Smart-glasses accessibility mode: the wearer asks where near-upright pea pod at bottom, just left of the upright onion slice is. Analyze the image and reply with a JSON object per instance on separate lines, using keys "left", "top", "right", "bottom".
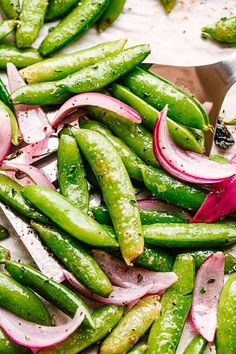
{"left": 147, "top": 254, "right": 195, "bottom": 354}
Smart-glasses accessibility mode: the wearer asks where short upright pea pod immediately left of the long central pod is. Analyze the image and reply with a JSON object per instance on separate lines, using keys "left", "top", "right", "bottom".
{"left": 57, "top": 134, "right": 89, "bottom": 213}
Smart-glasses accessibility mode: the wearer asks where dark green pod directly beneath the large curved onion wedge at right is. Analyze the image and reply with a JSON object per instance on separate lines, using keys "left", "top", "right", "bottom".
{"left": 141, "top": 165, "right": 207, "bottom": 210}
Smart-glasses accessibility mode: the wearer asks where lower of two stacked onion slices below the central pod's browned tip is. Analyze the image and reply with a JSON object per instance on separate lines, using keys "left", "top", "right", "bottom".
{"left": 64, "top": 271, "right": 152, "bottom": 305}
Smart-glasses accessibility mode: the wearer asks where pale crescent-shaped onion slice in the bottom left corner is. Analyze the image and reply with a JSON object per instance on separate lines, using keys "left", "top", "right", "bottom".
{"left": 0, "top": 307, "right": 84, "bottom": 349}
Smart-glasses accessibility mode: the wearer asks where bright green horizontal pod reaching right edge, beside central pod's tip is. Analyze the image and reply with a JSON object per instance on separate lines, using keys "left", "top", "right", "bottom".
{"left": 143, "top": 224, "right": 236, "bottom": 248}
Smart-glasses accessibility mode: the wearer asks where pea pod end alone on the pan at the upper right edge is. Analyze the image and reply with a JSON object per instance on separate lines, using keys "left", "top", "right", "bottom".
{"left": 202, "top": 16, "right": 236, "bottom": 44}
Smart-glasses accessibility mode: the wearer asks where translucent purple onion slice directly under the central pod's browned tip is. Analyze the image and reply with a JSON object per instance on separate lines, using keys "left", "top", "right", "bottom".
{"left": 92, "top": 250, "right": 178, "bottom": 294}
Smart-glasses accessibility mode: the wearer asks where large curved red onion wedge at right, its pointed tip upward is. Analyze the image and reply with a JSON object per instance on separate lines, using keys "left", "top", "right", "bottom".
{"left": 153, "top": 107, "right": 236, "bottom": 184}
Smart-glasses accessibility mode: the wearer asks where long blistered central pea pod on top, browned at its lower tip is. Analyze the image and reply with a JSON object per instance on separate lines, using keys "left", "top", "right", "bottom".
{"left": 73, "top": 128, "right": 144, "bottom": 265}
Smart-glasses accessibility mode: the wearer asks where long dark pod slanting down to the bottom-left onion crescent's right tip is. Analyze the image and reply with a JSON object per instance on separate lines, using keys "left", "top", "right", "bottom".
{"left": 5, "top": 261, "right": 94, "bottom": 328}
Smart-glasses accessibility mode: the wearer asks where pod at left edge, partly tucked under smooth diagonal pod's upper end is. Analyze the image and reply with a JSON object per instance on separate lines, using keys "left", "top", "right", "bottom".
{"left": 0, "top": 174, "right": 47, "bottom": 222}
